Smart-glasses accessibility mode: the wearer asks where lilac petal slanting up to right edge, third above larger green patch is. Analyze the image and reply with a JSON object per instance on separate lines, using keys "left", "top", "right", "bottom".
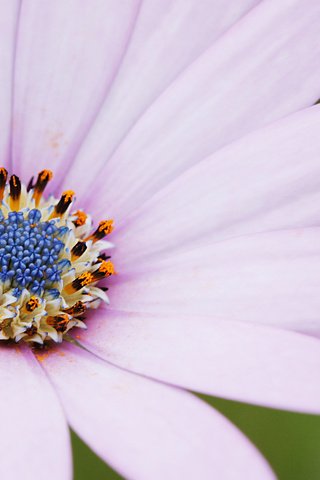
{"left": 114, "top": 107, "right": 320, "bottom": 265}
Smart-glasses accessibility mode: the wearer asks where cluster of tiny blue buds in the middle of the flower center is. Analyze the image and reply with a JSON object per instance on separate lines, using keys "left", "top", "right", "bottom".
{"left": 0, "top": 209, "right": 70, "bottom": 297}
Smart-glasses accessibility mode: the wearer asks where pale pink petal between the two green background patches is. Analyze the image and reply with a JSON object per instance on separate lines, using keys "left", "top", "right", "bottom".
{"left": 42, "top": 346, "right": 273, "bottom": 480}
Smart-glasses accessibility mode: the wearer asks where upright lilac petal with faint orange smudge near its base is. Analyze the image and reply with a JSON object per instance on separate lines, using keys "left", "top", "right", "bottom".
{"left": 13, "top": 0, "right": 138, "bottom": 187}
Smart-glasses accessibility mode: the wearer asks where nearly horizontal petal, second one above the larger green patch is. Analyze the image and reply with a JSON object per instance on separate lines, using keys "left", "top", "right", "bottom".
{"left": 109, "top": 229, "right": 320, "bottom": 335}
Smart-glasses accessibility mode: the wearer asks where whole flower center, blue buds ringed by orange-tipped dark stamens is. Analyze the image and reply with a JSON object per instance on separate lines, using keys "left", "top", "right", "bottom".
{"left": 0, "top": 168, "right": 114, "bottom": 344}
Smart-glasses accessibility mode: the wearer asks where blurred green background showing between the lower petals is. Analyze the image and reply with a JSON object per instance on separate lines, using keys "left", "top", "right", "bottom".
{"left": 72, "top": 396, "right": 320, "bottom": 480}
